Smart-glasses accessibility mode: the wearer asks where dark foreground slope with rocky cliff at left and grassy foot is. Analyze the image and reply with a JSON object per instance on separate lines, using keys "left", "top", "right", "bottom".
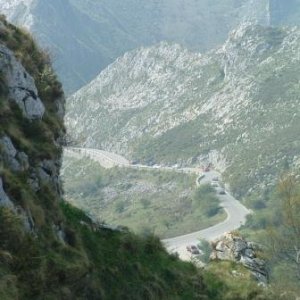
{"left": 0, "top": 19, "right": 267, "bottom": 300}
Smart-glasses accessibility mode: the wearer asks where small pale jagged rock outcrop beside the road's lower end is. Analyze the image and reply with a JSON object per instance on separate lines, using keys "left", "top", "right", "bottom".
{"left": 210, "top": 233, "right": 268, "bottom": 284}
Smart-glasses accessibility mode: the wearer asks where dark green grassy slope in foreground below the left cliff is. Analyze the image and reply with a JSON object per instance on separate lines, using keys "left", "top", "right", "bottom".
{"left": 0, "top": 203, "right": 205, "bottom": 300}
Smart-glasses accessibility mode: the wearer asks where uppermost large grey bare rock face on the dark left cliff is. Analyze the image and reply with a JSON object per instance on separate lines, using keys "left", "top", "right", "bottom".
{"left": 0, "top": 45, "right": 45, "bottom": 120}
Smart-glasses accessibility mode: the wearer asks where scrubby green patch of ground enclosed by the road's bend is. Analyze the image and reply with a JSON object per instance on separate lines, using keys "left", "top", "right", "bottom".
{"left": 63, "top": 157, "right": 225, "bottom": 237}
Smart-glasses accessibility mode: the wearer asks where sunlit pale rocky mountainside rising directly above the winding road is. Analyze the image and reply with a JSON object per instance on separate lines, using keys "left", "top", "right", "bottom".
{"left": 66, "top": 24, "right": 300, "bottom": 194}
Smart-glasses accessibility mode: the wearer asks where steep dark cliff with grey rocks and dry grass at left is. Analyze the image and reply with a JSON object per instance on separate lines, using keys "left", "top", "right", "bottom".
{"left": 0, "top": 18, "right": 65, "bottom": 238}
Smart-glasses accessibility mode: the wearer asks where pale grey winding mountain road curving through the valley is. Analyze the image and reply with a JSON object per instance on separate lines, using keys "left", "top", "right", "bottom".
{"left": 64, "top": 147, "right": 251, "bottom": 260}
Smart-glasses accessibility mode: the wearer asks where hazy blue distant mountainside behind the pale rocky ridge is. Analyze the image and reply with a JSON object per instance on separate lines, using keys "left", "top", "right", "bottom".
{"left": 0, "top": 0, "right": 269, "bottom": 92}
